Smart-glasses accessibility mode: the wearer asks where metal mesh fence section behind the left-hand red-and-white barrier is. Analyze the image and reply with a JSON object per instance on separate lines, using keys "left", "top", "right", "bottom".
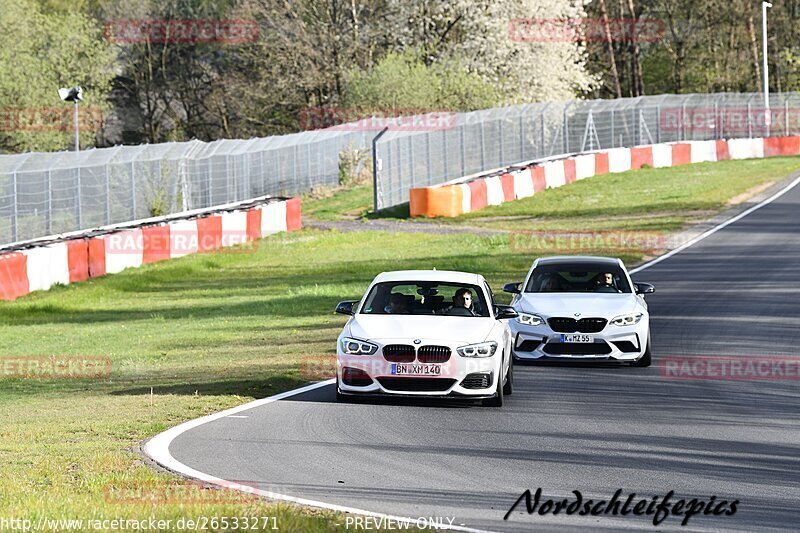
{"left": 0, "top": 130, "right": 374, "bottom": 244}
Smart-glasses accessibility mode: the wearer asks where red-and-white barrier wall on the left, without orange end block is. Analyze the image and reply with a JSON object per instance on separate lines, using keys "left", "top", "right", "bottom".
{"left": 0, "top": 198, "right": 302, "bottom": 300}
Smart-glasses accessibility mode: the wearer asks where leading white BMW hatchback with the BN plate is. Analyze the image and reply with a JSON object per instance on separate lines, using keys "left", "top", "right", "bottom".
{"left": 336, "top": 270, "right": 517, "bottom": 406}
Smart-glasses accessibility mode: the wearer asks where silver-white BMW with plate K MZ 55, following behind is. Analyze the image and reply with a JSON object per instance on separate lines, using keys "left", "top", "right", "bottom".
{"left": 503, "top": 256, "right": 655, "bottom": 366}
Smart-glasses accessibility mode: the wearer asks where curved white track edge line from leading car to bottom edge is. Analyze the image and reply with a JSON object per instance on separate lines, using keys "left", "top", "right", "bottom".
{"left": 142, "top": 379, "right": 490, "bottom": 533}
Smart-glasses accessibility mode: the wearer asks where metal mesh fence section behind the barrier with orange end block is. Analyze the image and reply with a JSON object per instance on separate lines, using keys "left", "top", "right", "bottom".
{"left": 374, "top": 93, "right": 800, "bottom": 209}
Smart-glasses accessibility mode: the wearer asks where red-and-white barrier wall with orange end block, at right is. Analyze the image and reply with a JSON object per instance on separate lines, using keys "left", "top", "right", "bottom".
{"left": 409, "top": 136, "right": 800, "bottom": 217}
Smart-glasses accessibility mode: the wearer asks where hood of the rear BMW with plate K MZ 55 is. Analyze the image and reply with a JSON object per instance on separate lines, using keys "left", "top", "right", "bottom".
{"left": 514, "top": 292, "right": 638, "bottom": 320}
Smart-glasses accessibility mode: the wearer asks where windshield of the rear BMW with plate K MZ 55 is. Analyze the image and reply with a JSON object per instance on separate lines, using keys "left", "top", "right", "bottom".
{"left": 525, "top": 263, "right": 631, "bottom": 294}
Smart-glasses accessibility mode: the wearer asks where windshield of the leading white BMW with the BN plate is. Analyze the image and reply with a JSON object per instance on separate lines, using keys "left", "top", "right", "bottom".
{"left": 361, "top": 281, "right": 489, "bottom": 317}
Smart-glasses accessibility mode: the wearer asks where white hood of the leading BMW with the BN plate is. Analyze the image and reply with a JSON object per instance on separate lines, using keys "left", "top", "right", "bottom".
{"left": 349, "top": 314, "right": 495, "bottom": 343}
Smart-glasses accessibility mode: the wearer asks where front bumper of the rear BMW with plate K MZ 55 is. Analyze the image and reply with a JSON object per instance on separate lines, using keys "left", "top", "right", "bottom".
{"left": 511, "top": 318, "right": 649, "bottom": 363}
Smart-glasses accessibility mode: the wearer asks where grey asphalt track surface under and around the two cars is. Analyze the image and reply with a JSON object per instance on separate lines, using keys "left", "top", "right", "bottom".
{"left": 169, "top": 178, "right": 800, "bottom": 531}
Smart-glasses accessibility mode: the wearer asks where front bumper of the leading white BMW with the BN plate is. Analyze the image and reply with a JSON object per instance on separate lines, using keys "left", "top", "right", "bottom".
{"left": 336, "top": 341, "right": 501, "bottom": 399}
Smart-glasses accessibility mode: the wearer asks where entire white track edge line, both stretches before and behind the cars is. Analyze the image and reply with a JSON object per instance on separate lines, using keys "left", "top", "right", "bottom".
{"left": 143, "top": 172, "right": 800, "bottom": 533}
